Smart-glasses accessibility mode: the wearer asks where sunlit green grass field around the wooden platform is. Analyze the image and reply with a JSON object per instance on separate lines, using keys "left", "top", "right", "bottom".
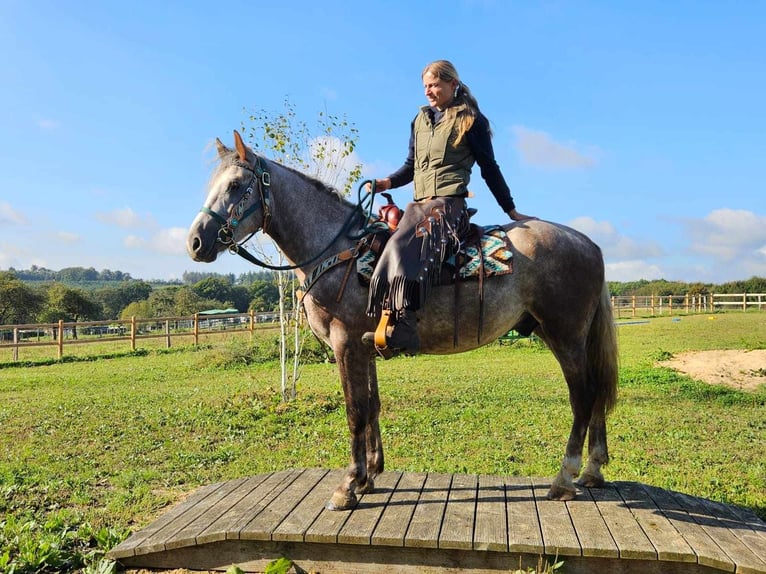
{"left": 0, "top": 312, "right": 766, "bottom": 573}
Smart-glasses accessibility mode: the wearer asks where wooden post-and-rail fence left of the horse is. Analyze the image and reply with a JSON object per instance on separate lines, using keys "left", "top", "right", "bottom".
{"left": 0, "top": 311, "right": 279, "bottom": 362}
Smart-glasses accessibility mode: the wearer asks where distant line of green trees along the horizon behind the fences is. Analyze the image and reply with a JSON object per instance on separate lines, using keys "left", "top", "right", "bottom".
{"left": 0, "top": 266, "right": 766, "bottom": 325}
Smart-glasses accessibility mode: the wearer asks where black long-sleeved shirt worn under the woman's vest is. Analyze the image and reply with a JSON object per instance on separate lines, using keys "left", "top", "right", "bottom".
{"left": 389, "top": 108, "right": 515, "bottom": 213}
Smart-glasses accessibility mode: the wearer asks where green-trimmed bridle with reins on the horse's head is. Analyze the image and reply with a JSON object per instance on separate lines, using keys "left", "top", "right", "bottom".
{"left": 200, "top": 155, "right": 375, "bottom": 271}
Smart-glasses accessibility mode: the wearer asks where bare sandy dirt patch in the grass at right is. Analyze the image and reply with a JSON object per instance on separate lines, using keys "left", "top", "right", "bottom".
{"left": 657, "top": 349, "right": 766, "bottom": 391}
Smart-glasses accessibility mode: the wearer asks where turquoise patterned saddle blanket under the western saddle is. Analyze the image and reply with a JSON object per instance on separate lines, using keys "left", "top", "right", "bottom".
{"left": 356, "top": 225, "right": 513, "bottom": 282}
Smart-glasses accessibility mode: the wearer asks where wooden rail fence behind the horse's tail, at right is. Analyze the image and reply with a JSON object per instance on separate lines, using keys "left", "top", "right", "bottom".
{"left": 612, "top": 293, "right": 766, "bottom": 319}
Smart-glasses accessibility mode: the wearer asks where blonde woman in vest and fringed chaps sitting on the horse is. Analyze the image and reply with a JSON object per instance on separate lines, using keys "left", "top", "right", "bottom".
{"left": 362, "top": 60, "right": 530, "bottom": 354}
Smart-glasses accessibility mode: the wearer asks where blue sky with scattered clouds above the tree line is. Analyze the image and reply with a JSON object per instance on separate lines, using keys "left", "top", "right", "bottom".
{"left": 0, "top": 0, "right": 766, "bottom": 283}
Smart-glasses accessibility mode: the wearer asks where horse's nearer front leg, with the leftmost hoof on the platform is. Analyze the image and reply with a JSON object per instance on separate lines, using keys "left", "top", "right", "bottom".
{"left": 326, "top": 344, "right": 370, "bottom": 510}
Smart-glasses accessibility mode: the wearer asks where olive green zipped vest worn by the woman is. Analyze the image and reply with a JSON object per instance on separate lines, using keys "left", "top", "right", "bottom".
{"left": 414, "top": 104, "right": 475, "bottom": 200}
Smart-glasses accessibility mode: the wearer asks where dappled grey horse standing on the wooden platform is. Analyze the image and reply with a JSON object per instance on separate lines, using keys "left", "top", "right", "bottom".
{"left": 186, "top": 131, "right": 618, "bottom": 510}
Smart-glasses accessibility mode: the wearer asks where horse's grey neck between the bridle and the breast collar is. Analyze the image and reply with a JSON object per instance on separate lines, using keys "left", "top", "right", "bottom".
{"left": 268, "top": 165, "right": 352, "bottom": 280}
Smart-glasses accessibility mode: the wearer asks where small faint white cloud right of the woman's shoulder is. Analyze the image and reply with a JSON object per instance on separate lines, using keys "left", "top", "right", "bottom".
{"left": 513, "top": 126, "right": 598, "bottom": 169}
